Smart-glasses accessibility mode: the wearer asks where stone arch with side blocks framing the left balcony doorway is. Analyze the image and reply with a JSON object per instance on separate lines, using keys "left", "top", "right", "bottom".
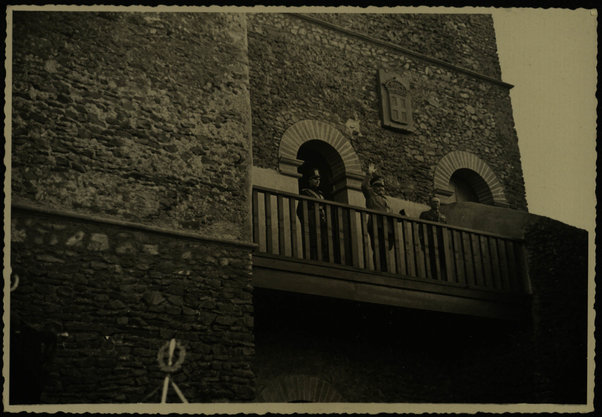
{"left": 278, "top": 120, "right": 362, "bottom": 179}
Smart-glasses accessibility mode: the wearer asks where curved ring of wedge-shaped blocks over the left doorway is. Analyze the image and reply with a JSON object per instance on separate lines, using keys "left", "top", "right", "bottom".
{"left": 278, "top": 120, "right": 361, "bottom": 173}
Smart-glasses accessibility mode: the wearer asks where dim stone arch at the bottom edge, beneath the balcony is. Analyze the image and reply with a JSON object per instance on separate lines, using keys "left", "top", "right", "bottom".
{"left": 255, "top": 375, "right": 344, "bottom": 403}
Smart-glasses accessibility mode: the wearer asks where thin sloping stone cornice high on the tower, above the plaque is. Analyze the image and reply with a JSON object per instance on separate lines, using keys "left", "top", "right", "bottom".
{"left": 290, "top": 13, "right": 514, "bottom": 89}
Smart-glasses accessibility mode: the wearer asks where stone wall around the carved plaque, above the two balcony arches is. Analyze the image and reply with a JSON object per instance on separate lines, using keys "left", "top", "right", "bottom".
{"left": 248, "top": 14, "right": 526, "bottom": 210}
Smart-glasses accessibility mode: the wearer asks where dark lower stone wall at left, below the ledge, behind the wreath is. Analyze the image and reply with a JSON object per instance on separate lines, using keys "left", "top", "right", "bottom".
{"left": 11, "top": 210, "right": 254, "bottom": 403}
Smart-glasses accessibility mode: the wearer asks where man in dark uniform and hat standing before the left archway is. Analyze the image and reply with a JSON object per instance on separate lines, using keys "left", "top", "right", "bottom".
{"left": 297, "top": 169, "right": 328, "bottom": 261}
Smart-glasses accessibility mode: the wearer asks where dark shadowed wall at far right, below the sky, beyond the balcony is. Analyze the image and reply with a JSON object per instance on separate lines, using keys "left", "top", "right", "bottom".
{"left": 525, "top": 216, "right": 588, "bottom": 403}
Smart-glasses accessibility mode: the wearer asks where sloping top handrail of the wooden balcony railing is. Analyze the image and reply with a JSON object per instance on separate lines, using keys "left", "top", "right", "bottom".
{"left": 253, "top": 185, "right": 524, "bottom": 242}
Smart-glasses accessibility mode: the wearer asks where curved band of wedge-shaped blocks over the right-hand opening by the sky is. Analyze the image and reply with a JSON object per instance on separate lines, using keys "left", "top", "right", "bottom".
{"left": 433, "top": 151, "right": 507, "bottom": 205}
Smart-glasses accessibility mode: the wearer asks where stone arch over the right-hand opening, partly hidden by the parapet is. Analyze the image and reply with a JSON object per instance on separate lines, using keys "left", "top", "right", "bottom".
{"left": 433, "top": 151, "right": 508, "bottom": 207}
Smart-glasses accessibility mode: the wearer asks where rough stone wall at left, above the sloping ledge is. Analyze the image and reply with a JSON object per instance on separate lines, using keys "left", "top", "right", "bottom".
{"left": 12, "top": 12, "right": 251, "bottom": 239}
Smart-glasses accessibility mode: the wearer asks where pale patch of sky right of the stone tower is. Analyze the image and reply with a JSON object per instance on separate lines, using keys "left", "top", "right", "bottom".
{"left": 491, "top": 8, "right": 597, "bottom": 235}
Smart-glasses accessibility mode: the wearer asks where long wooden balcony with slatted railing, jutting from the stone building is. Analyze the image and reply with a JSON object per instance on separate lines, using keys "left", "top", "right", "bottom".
{"left": 252, "top": 186, "right": 531, "bottom": 319}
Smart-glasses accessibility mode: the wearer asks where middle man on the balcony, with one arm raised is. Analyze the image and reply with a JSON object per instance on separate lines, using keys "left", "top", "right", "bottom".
{"left": 362, "top": 164, "right": 395, "bottom": 271}
